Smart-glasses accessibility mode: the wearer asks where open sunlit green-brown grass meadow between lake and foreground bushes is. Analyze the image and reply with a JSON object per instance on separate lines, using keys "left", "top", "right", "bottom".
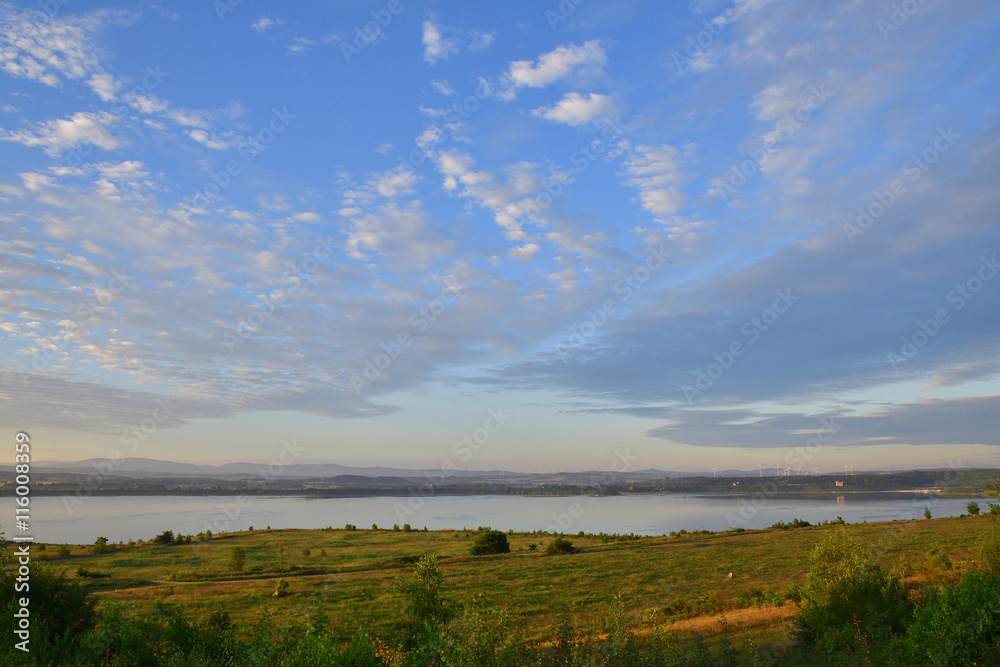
{"left": 36, "top": 516, "right": 990, "bottom": 641}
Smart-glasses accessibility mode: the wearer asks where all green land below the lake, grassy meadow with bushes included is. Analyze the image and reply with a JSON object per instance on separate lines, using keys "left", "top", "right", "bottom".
{"left": 0, "top": 490, "right": 1000, "bottom": 666}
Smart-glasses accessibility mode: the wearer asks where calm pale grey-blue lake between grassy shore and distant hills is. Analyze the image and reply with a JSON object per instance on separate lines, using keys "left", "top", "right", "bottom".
{"left": 27, "top": 494, "right": 987, "bottom": 544}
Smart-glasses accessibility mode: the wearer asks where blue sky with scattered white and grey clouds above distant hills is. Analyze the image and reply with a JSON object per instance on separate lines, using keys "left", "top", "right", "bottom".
{"left": 0, "top": 0, "right": 1000, "bottom": 473}
